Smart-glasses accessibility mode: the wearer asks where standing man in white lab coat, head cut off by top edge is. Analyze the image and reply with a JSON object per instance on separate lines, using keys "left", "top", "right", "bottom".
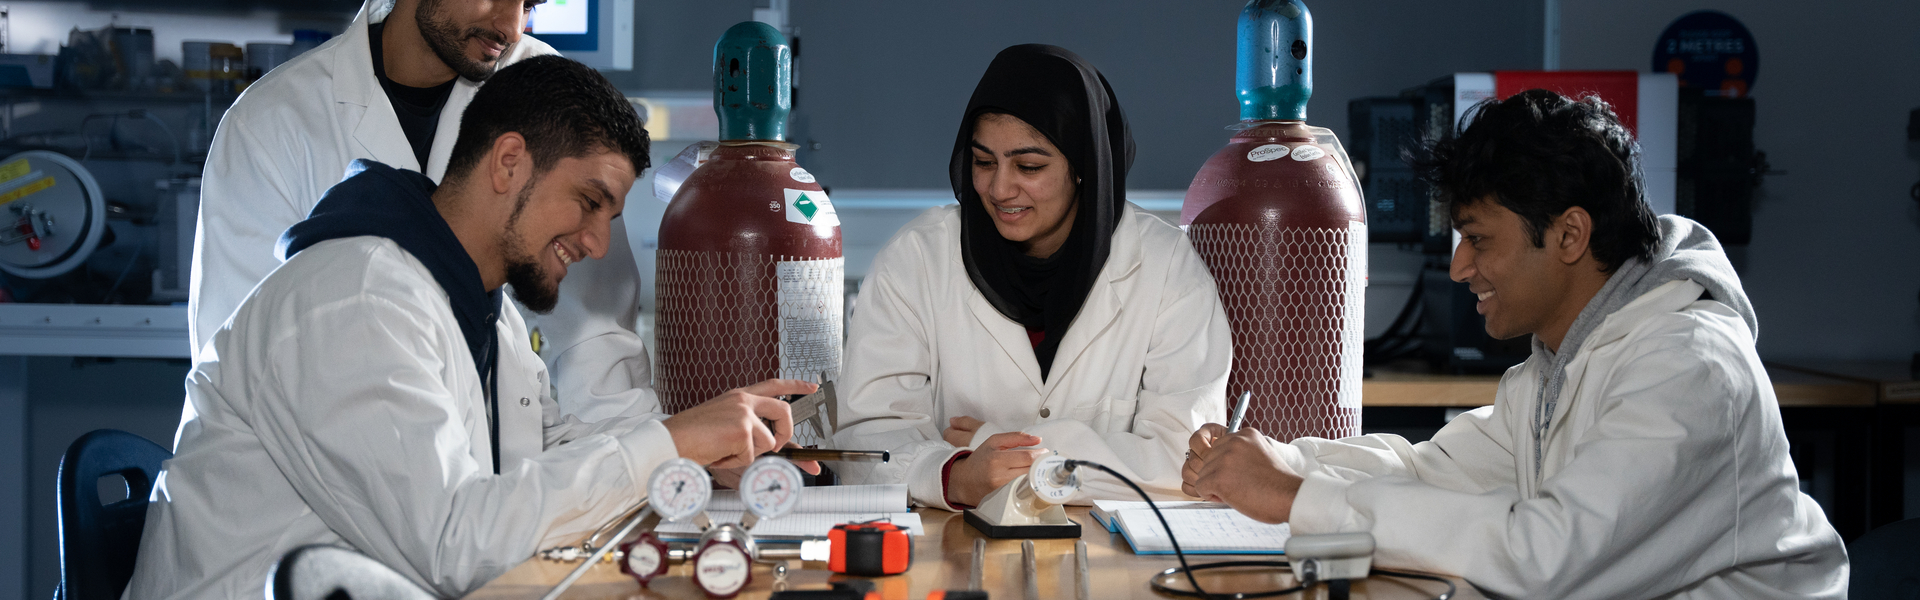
{"left": 188, "top": 0, "right": 659, "bottom": 430}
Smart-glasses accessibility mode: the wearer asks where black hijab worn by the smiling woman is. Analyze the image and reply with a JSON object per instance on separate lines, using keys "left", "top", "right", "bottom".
{"left": 948, "top": 44, "right": 1133, "bottom": 379}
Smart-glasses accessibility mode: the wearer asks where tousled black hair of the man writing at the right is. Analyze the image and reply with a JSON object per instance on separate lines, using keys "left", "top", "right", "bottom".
{"left": 1413, "top": 88, "right": 1659, "bottom": 273}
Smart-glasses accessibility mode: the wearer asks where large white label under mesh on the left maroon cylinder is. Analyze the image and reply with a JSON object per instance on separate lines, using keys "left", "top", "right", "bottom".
{"left": 774, "top": 258, "right": 847, "bottom": 383}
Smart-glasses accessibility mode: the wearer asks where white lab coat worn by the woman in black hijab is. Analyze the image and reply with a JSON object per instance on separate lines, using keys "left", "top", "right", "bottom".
{"left": 833, "top": 204, "right": 1233, "bottom": 510}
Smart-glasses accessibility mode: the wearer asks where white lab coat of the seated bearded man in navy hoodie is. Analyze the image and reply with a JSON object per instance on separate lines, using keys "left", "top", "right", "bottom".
{"left": 125, "top": 237, "right": 678, "bottom": 600}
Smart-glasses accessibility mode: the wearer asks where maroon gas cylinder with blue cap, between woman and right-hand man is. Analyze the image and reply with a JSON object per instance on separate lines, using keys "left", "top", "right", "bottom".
{"left": 1181, "top": 0, "right": 1367, "bottom": 440}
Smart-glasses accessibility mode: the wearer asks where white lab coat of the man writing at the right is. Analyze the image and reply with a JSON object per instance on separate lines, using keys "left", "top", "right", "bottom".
{"left": 1281, "top": 279, "right": 1847, "bottom": 598}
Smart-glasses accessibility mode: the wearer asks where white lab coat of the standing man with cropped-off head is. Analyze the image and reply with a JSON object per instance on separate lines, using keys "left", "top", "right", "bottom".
{"left": 188, "top": 0, "right": 659, "bottom": 421}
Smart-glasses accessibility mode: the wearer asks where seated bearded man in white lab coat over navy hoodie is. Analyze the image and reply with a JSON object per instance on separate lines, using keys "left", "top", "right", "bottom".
{"left": 127, "top": 56, "right": 814, "bottom": 598}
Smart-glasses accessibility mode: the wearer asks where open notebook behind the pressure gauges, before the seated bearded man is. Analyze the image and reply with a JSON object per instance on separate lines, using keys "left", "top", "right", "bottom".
{"left": 653, "top": 485, "right": 925, "bottom": 542}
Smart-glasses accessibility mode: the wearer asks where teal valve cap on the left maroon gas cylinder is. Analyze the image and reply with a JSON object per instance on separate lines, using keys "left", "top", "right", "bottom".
{"left": 714, "top": 21, "right": 793, "bottom": 140}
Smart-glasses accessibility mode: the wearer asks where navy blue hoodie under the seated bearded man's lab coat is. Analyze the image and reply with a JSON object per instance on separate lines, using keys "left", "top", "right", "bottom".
{"left": 278, "top": 158, "right": 505, "bottom": 469}
